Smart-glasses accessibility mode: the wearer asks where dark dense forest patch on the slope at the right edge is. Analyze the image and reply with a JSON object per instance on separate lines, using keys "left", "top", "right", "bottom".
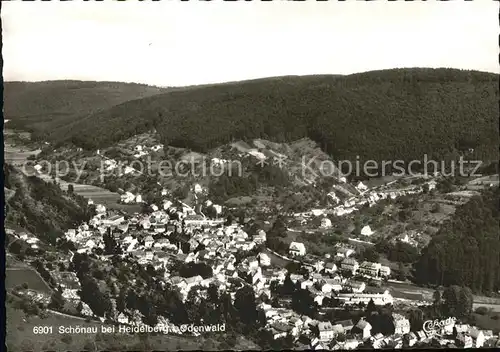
{"left": 415, "top": 187, "right": 500, "bottom": 293}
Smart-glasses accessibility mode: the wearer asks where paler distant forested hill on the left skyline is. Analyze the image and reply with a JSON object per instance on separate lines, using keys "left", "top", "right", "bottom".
{"left": 4, "top": 81, "right": 166, "bottom": 134}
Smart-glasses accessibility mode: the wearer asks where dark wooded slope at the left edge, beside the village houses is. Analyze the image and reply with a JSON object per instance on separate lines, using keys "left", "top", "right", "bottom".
{"left": 3, "top": 164, "right": 93, "bottom": 244}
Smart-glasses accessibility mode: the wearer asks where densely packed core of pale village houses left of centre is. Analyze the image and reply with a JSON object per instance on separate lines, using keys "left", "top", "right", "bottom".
{"left": 66, "top": 197, "right": 278, "bottom": 304}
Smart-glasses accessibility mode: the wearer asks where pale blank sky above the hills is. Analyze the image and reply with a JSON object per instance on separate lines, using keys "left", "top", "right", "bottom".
{"left": 1, "top": 0, "right": 500, "bottom": 86}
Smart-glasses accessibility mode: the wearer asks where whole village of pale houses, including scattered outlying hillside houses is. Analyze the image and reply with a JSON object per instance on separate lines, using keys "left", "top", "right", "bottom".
{"left": 6, "top": 131, "right": 498, "bottom": 350}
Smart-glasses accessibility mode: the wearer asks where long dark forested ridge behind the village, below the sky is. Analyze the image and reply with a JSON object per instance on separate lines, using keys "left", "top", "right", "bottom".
{"left": 23, "top": 68, "right": 499, "bottom": 164}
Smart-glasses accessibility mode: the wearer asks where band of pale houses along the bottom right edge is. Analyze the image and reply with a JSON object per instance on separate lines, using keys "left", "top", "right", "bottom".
{"left": 258, "top": 303, "right": 500, "bottom": 350}
